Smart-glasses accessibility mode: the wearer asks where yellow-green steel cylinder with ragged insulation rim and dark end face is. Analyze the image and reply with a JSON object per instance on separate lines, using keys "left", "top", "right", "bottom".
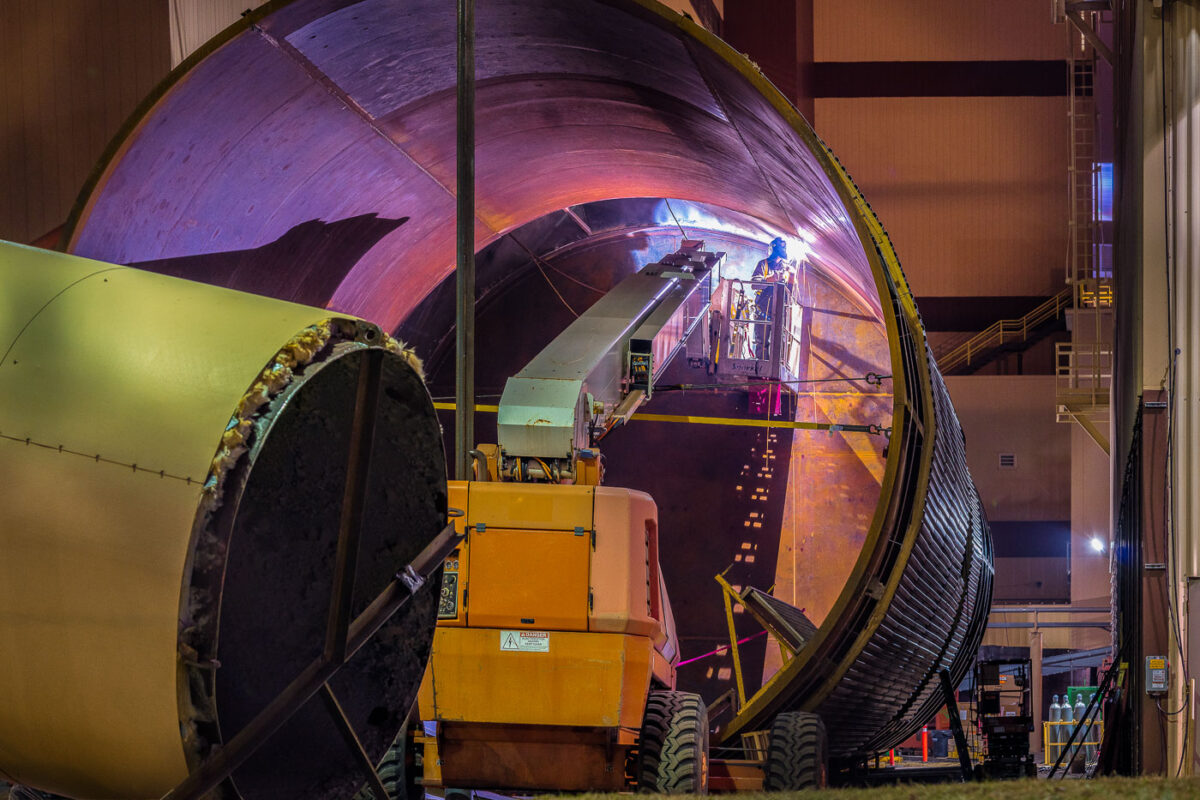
{"left": 0, "top": 243, "right": 446, "bottom": 800}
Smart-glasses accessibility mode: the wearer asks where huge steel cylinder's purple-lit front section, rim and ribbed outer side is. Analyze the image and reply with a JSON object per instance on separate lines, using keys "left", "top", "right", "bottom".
{"left": 60, "top": 0, "right": 992, "bottom": 756}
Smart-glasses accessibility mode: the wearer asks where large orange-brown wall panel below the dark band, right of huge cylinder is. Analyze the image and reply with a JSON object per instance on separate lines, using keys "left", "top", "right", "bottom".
{"left": 816, "top": 97, "right": 1068, "bottom": 297}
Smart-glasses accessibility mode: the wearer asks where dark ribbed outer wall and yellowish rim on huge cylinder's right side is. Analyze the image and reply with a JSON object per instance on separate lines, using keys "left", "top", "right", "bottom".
{"left": 720, "top": 160, "right": 992, "bottom": 757}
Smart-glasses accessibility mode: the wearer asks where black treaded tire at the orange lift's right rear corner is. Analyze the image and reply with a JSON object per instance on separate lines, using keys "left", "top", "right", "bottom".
{"left": 637, "top": 692, "right": 708, "bottom": 794}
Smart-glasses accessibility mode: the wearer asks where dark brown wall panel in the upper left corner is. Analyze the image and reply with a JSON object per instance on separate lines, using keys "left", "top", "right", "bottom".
{"left": 0, "top": 0, "right": 169, "bottom": 242}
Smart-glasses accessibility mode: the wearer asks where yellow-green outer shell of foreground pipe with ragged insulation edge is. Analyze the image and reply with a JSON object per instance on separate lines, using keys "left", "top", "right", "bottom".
{"left": 0, "top": 242, "right": 444, "bottom": 799}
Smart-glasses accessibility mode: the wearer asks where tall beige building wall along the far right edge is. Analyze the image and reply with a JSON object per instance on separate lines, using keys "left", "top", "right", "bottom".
{"left": 1112, "top": 0, "right": 1200, "bottom": 774}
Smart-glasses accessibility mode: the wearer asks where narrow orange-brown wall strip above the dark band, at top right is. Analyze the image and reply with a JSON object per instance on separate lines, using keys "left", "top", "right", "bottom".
{"left": 812, "top": 0, "right": 1067, "bottom": 61}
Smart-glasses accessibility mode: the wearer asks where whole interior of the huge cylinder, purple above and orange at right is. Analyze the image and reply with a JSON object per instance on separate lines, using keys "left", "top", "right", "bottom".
{"left": 70, "top": 0, "right": 893, "bottom": 698}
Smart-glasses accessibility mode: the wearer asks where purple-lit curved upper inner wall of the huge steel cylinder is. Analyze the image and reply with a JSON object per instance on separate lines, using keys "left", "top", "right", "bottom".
{"left": 70, "top": 0, "right": 878, "bottom": 327}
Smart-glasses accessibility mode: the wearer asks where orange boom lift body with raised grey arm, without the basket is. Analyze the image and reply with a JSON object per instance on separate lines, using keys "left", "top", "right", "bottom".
{"left": 412, "top": 241, "right": 724, "bottom": 793}
